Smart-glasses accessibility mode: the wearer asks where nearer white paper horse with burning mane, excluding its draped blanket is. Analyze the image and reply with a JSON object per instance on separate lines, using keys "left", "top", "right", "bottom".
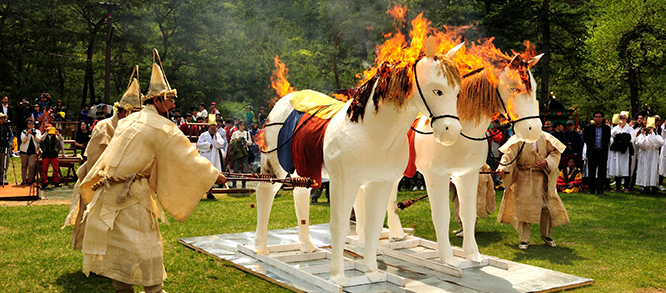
{"left": 255, "top": 37, "right": 462, "bottom": 285}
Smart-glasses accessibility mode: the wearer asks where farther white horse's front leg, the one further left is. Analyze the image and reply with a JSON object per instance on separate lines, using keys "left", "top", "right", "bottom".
{"left": 422, "top": 172, "right": 460, "bottom": 267}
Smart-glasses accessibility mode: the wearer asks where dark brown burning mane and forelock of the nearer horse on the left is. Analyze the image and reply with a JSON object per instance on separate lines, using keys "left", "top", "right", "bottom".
{"left": 347, "top": 54, "right": 462, "bottom": 122}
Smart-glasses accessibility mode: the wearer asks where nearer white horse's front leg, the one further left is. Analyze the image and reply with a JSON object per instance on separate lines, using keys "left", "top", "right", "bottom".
{"left": 329, "top": 177, "right": 359, "bottom": 286}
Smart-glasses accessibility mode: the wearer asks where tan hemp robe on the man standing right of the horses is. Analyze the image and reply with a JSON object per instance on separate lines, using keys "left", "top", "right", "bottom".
{"left": 497, "top": 132, "right": 569, "bottom": 230}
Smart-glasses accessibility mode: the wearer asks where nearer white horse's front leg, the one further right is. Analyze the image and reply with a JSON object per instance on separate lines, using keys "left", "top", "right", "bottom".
{"left": 361, "top": 181, "right": 393, "bottom": 282}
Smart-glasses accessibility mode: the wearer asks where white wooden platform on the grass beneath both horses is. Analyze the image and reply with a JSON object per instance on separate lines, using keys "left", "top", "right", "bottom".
{"left": 178, "top": 224, "right": 594, "bottom": 293}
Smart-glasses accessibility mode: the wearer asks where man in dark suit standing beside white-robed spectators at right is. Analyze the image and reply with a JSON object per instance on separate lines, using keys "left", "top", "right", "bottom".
{"left": 583, "top": 111, "right": 610, "bottom": 194}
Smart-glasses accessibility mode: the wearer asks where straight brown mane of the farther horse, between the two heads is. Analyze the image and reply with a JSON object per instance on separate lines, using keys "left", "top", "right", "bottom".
{"left": 457, "top": 69, "right": 499, "bottom": 124}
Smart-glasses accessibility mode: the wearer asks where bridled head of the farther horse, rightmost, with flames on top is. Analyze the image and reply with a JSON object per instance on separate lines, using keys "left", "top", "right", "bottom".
{"left": 497, "top": 54, "right": 543, "bottom": 143}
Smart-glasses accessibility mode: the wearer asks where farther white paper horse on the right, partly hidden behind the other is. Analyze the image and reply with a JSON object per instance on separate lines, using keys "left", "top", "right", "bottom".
{"left": 356, "top": 55, "right": 542, "bottom": 266}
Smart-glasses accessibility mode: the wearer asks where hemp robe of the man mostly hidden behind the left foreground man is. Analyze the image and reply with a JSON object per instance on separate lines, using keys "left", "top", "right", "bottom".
{"left": 62, "top": 113, "right": 120, "bottom": 250}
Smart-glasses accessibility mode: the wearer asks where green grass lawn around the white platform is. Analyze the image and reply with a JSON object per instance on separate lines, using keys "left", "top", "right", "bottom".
{"left": 0, "top": 187, "right": 666, "bottom": 292}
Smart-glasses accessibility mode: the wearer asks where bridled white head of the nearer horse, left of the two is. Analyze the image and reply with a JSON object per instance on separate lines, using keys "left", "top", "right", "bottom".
{"left": 412, "top": 36, "right": 464, "bottom": 146}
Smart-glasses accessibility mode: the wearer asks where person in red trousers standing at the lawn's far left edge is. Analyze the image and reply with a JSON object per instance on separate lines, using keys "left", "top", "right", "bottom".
{"left": 39, "top": 124, "right": 63, "bottom": 188}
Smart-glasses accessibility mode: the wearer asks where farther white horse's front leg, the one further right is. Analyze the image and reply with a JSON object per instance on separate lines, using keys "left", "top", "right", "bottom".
{"left": 456, "top": 170, "right": 481, "bottom": 262}
